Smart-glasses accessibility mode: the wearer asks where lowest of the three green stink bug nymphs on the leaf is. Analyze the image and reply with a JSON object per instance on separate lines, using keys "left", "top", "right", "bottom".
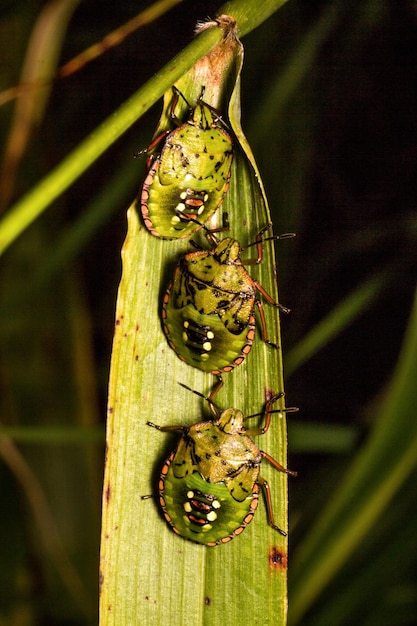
{"left": 148, "top": 385, "right": 296, "bottom": 547}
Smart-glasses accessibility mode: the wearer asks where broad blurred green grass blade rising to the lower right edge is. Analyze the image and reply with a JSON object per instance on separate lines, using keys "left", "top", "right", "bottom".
{"left": 290, "top": 284, "right": 417, "bottom": 624}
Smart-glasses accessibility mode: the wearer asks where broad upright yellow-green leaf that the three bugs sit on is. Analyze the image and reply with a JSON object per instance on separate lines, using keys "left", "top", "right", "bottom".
{"left": 100, "top": 3, "right": 287, "bottom": 626}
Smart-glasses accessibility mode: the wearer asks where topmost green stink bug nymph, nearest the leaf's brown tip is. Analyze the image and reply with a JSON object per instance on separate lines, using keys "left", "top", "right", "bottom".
{"left": 141, "top": 88, "right": 233, "bottom": 239}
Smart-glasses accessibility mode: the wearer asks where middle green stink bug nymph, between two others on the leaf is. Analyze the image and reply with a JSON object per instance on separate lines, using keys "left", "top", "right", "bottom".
{"left": 162, "top": 226, "right": 294, "bottom": 376}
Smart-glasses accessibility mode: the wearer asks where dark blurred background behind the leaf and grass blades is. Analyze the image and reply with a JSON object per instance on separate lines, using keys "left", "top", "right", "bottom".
{"left": 0, "top": 0, "right": 417, "bottom": 625}
